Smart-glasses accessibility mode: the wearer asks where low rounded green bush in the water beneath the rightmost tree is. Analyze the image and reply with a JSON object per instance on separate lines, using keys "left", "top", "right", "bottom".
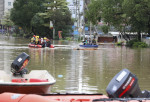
{"left": 126, "top": 39, "right": 148, "bottom": 48}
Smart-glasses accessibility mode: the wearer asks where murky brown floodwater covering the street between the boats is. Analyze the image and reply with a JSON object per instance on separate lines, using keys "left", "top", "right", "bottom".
{"left": 0, "top": 36, "right": 150, "bottom": 94}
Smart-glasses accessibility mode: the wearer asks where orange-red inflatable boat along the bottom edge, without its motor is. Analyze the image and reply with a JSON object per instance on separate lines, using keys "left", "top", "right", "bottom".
{"left": 0, "top": 93, "right": 150, "bottom": 102}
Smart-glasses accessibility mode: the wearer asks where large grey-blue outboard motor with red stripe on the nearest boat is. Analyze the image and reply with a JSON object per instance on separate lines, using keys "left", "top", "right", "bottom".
{"left": 106, "top": 69, "right": 150, "bottom": 98}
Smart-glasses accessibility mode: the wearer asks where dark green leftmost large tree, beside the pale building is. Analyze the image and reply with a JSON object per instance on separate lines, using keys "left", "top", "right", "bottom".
{"left": 10, "top": 0, "right": 44, "bottom": 34}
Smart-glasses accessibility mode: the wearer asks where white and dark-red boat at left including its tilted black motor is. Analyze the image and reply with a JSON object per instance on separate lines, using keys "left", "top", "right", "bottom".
{"left": 0, "top": 52, "right": 56, "bottom": 94}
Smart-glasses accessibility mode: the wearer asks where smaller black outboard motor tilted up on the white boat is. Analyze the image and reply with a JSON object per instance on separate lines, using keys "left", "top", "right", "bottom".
{"left": 11, "top": 52, "right": 30, "bottom": 76}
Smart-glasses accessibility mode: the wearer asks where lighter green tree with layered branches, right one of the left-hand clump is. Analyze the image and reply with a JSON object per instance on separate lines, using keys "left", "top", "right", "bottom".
{"left": 39, "top": 0, "right": 73, "bottom": 37}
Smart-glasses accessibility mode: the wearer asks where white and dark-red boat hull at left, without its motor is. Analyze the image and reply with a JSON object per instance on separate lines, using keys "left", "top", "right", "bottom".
{"left": 0, "top": 70, "right": 56, "bottom": 94}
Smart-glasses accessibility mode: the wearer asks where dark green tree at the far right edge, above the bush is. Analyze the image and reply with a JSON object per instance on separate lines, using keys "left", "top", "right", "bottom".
{"left": 122, "top": 0, "right": 150, "bottom": 40}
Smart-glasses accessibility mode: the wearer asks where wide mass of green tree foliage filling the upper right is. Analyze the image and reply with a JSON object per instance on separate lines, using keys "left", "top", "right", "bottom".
{"left": 87, "top": 0, "right": 150, "bottom": 39}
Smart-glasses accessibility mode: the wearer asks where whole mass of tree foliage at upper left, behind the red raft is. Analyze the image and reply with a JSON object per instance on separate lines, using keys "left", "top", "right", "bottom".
{"left": 10, "top": 0, "right": 72, "bottom": 38}
